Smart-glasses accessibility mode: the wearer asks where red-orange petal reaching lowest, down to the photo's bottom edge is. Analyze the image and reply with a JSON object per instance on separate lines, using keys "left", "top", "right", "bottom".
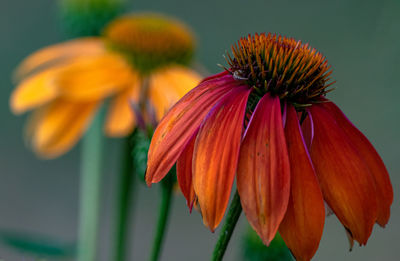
{"left": 279, "top": 105, "right": 325, "bottom": 261}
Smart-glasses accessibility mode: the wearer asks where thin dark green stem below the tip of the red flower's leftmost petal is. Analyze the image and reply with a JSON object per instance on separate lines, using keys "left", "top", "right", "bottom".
{"left": 150, "top": 171, "right": 174, "bottom": 261}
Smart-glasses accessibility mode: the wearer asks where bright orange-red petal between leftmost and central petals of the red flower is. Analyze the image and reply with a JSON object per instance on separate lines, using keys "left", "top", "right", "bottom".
{"left": 193, "top": 86, "right": 251, "bottom": 231}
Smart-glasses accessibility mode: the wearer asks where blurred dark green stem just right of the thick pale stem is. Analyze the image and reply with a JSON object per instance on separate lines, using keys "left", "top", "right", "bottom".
{"left": 112, "top": 134, "right": 136, "bottom": 261}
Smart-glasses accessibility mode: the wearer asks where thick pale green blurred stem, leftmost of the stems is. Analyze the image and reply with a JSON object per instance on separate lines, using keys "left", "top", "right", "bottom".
{"left": 77, "top": 110, "right": 104, "bottom": 261}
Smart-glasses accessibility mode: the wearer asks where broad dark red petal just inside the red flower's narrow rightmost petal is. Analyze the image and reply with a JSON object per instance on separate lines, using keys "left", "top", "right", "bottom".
{"left": 310, "top": 104, "right": 377, "bottom": 244}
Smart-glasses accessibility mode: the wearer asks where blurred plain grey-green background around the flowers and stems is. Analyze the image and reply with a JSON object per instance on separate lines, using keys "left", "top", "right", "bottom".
{"left": 0, "top": 0, "right": 400, "bottom": 261}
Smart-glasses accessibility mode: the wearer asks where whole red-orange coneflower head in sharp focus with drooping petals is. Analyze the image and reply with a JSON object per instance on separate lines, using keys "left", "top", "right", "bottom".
{"left": 146, "top": 34, "right": 393, "bottom": 260}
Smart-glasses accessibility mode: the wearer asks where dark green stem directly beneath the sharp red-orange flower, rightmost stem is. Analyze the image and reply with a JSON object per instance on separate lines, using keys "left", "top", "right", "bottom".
{"left": 211, "top": 191, "right": 242, "bottom": 261}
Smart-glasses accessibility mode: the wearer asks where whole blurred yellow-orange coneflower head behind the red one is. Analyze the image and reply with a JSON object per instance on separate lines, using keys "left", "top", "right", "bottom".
{"left": 10, "top": 14, "right": 200, "bottom": 157}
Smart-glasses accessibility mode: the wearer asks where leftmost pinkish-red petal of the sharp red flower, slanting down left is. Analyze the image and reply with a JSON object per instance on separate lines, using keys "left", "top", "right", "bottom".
{"left": 146, "top": 75, "right": 238, "bottom": 186}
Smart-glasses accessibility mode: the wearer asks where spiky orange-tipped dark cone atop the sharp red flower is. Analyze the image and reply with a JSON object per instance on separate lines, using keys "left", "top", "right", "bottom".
{"left": 227, "top": 33, "right": 334, "bottom": 108}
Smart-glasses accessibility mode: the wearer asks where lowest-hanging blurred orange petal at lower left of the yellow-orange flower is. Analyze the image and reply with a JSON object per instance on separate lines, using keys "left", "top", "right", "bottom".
{"left": 30, "top": 100, "right": 98, "bottom": 158}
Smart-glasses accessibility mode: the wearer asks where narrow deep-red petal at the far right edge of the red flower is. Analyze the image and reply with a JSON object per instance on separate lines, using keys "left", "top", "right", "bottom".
{"left": 321, "top": 101, "right": 393, "bottom": 226}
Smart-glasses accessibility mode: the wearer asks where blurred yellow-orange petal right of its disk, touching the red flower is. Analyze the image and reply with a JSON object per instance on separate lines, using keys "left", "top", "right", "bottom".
{"left": 149, "top": 66, "right": 201, "bottom": 120}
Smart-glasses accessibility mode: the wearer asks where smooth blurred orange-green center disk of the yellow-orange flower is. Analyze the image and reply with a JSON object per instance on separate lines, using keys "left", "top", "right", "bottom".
{"left": 105, "top": 14, "right": 194, "bottom": 73}
